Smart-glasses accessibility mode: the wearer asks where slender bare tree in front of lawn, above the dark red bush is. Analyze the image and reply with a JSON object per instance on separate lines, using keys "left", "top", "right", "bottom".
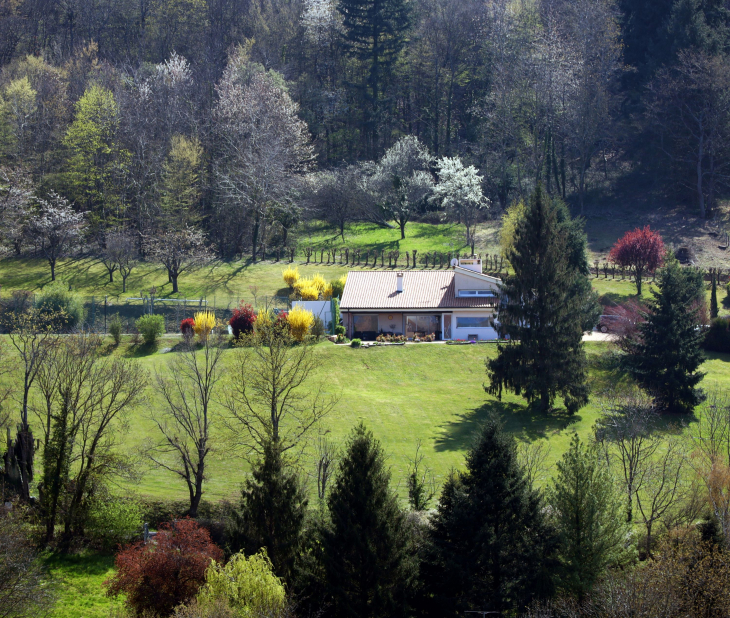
{"left": 147, "top": 339, "right": 223, "bottom": 517}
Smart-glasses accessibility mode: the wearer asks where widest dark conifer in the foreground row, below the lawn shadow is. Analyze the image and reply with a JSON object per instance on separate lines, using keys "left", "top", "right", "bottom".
{"left": 422, "top": 417, "right": 556, "bottom": 616}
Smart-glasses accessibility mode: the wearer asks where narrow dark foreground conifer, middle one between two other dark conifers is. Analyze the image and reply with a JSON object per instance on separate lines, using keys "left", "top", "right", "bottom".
{"left": 322, "top": 424, "right": 415, "bottom": 618}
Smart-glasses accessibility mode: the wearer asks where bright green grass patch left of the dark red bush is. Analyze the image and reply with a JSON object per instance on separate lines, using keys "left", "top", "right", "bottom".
{"left": 44, "top": 553, "right": 122, "bottom": 618}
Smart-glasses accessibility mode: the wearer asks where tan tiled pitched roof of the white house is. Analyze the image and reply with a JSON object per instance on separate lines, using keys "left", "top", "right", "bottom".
{"left": 340, "top": 270, "right": 497, "bottom": 311}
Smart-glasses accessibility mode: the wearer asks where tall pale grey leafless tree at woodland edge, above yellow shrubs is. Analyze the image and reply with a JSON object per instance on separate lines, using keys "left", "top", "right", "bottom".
{"left": 215, "top": 48, "right": 313, "bottom": 262}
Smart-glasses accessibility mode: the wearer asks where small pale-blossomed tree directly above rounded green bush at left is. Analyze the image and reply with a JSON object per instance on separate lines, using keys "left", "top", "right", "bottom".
{"left": 28, "top": 192, "right": 84, "bottom": 281}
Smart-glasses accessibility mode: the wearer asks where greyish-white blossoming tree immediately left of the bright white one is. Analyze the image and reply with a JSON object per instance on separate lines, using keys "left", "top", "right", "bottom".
{"left": 369, "top": 135, "right": 433, "bottom": 239}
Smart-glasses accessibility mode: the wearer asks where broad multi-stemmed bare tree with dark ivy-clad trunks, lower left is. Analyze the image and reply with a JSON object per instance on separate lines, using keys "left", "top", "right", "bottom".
{"left": 39, "top": 333, "right": 147, "bottom": 549}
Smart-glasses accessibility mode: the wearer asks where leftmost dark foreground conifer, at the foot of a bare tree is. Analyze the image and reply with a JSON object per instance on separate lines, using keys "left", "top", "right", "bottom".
{"left": 230, "top": 443, "right": 308, "bottom": 581}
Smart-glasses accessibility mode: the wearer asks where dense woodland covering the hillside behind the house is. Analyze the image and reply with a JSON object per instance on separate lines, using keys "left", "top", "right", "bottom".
{"left": 0, "top": 0, "right": 730, "bottom": 260}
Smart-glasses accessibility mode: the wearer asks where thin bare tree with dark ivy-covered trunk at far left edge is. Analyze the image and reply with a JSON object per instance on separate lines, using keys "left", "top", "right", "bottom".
{"left": 6, "top": 309, "right": 56, "bottom": 500}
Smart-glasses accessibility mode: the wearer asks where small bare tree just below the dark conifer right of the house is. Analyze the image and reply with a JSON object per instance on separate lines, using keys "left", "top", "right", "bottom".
{"left": 596, "top": 391, "right": 662, "bottom": 522}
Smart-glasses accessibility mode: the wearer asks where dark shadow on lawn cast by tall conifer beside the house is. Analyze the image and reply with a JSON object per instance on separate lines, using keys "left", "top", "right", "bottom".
{"left": 435, "top": 400, "right": 582, "bottom": 451}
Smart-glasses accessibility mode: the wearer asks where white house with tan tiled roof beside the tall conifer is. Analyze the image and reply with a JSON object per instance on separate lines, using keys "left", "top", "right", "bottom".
{"left": 340, "top": 258, "right": 501, "bottom": 340}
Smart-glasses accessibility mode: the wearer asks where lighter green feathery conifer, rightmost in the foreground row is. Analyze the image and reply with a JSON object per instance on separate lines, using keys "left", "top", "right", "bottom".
{"left": 547, "top": 434, "right": 632, "bottom": 603}
